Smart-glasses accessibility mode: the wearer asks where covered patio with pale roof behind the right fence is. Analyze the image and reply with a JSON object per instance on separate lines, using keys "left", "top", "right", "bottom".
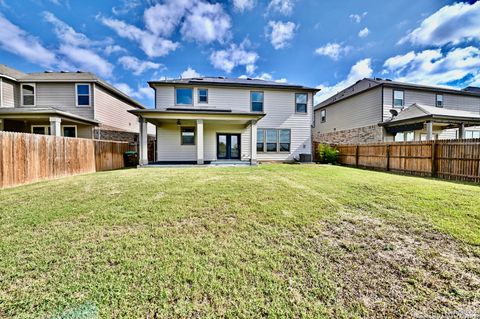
{"left": 378, "top": 104, "right": 480, "bottom": 141}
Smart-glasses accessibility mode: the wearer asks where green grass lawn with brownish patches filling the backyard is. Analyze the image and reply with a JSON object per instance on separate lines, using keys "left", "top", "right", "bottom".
{"left": 0, "top": 165, "right": 480, "bottom": 318}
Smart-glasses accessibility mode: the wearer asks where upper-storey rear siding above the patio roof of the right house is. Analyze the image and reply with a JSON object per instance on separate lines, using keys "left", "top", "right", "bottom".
{"left": 383, "top": 88, "right": 480, "bottom": 120}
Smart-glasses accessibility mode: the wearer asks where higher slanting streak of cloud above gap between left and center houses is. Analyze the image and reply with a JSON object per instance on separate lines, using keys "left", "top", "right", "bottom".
{"left": 100, "top": 17, "right": 179, "bottom": 57}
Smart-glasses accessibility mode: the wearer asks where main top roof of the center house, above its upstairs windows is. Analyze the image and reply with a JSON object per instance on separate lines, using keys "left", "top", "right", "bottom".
{"left": 148, "top": 77, "right": 320, "bottom": 92}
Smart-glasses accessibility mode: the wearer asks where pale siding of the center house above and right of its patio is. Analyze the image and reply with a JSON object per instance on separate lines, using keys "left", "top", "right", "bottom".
{"left": 155, "top": 85, "right": 316, "bottom": 161}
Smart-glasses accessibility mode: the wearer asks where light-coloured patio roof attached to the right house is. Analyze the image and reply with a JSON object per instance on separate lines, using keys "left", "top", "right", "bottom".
{"left": 380, "top": 103, "right": 480, "bottom": 125}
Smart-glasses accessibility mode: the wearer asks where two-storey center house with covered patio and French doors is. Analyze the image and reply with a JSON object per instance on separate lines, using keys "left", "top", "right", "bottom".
{"left": 130, "top": 77, "right": 318, "bottom": 164}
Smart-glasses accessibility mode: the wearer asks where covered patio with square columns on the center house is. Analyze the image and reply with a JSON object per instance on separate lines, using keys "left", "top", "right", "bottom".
{"left": 129, "top": 108, "right": 265, "bottom": 165}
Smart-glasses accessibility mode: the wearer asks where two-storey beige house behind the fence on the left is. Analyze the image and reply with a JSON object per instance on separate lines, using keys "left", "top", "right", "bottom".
{"left": 0, "top": 65, "right": 144, "bottom": 142}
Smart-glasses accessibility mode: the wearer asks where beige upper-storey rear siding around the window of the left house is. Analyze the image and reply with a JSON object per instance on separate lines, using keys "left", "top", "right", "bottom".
{"left": 35, "top": 82, "right": 95, "bottom": 119}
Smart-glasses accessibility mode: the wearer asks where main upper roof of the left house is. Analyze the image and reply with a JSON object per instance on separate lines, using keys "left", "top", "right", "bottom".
{"left": 0, "top": 64, "right": 145, "bottom": 109}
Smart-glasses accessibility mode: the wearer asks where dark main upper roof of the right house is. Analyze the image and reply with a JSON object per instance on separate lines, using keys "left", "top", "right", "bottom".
{"left": 314, "top": 78, "right": 480, "bottom": 110}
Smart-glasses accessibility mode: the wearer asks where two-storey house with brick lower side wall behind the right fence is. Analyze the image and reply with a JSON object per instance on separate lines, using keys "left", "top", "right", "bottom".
{"left": 313, "top": 78, "right": 480, "bottom": 143}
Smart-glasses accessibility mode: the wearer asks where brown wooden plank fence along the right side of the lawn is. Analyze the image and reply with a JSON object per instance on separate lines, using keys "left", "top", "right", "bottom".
{"left": 315, "top": 139, "right": 480, "bottom": 183}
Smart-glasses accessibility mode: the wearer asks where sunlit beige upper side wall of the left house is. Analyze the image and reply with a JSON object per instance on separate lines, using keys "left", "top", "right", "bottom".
{"left": 93, "top": 85, "right": 139, "bottom": 133}
